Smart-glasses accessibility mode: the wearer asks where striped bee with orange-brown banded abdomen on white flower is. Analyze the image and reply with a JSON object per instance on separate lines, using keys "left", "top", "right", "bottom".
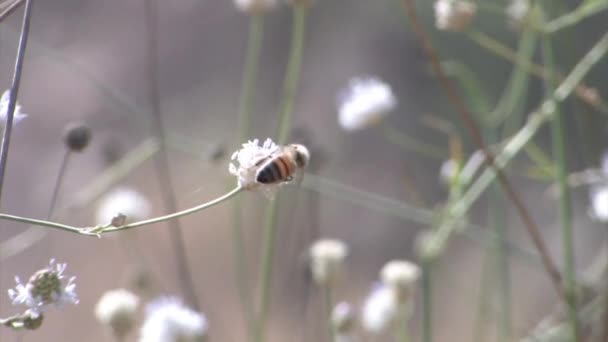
{"left": 255, "top": 144, "right": 310, "bottom": 184}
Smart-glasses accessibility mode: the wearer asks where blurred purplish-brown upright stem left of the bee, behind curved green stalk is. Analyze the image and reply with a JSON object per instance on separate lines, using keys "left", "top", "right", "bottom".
{"left": 144, "top": 0, "right": 200, "bottom": 310}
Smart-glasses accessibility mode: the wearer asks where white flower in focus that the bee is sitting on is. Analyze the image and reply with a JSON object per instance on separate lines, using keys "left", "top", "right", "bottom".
{"left": 228, "top": 138, "right": 282, "bottom": 195}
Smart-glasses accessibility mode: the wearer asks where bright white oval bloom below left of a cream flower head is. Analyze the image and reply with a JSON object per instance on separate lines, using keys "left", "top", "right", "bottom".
{"left": 362, "top": 284, "right": 399, "bottom": 334}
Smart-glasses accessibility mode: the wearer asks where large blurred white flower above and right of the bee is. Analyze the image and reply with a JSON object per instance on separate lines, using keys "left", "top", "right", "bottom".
{"left": 338, "top": 77, "right": 397, "bottom": 131}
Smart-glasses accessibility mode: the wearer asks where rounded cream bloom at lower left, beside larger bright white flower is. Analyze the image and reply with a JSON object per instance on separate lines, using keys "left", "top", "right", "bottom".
{"left": 95, "top": 289, "right": 139, "bottom": 340}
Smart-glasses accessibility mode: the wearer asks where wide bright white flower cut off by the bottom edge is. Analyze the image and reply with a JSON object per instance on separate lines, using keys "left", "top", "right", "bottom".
{"left": 139, "top": 297, "right": 209, "bottom": 342}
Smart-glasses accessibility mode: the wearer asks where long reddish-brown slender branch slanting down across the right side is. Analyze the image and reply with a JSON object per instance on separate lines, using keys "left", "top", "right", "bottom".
{"left": 403, "top": 0, "right": 563, "bottom": 295}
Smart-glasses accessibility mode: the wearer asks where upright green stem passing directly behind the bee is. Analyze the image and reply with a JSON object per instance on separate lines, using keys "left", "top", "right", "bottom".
{"left": 255, "top": 5, "right": 308, "bottom": 342}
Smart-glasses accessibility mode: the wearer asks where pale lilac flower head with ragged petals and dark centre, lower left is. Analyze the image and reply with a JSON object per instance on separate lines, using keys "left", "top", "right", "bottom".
{"left": 8, "top": 259, "right": 78, "bottom": 312}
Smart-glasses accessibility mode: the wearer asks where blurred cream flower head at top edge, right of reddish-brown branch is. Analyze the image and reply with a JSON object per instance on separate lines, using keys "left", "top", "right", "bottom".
{"left": 434, "top": 0, "right": 477, "bottom": 31}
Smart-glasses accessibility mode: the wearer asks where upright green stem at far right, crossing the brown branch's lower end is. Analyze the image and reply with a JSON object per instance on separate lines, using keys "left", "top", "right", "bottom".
{"left": 542, "top": 27, "right": 579, "bottom": 341}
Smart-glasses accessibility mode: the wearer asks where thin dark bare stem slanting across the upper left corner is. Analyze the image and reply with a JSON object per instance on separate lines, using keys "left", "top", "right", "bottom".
{"left": 0, "top": 0, "right": 34, "bottom": 203}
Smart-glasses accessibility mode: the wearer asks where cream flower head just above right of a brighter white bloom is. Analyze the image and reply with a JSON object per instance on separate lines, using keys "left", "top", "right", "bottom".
{"left": 380, "top": 260, "right": 420, "bottom": 303}
